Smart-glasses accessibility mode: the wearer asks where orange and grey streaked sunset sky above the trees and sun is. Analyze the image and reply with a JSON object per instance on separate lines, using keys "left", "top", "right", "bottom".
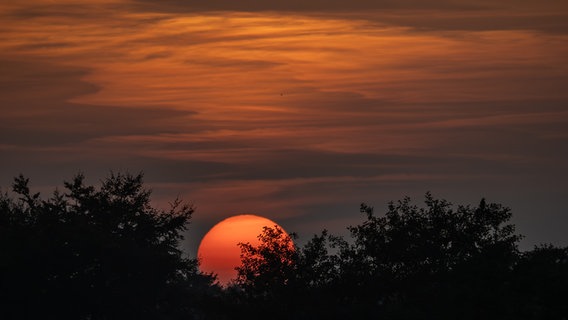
{"left": 0, "top": 0, "right": 568, "bottom": 255}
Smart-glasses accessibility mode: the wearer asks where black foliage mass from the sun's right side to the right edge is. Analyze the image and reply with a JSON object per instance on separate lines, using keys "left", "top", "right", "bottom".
{"left": 233, "top": 194, "right": 568, "bottom": 319}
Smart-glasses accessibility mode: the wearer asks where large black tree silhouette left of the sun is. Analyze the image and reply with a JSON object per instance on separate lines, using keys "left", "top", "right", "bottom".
{"left": 0, "top": 174, "right": 211, "bottom": 319}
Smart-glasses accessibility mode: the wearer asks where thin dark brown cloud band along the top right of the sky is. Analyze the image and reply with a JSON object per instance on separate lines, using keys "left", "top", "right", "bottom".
{"left": 129, "top": 0, "right": 568, "bottom": 33}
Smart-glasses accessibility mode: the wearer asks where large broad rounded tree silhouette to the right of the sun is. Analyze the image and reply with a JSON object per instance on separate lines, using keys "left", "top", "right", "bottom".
{"left": 330, "top": 193, "right": 520, "bottom": 318}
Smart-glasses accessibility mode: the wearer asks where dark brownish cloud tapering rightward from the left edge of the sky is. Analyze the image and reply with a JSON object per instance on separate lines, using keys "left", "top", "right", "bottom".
{"left": 0, "top": 58, "right": 195, "bottom": 147}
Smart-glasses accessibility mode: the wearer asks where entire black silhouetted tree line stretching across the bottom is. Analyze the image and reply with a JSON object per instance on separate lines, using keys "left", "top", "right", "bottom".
{"left": 0, "top": 174, "right": 568, "bottom": 319}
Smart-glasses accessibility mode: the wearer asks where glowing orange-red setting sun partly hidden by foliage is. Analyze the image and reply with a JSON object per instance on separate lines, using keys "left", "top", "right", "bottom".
{"left": 197, "top": 214, "right": 288, "bottom": 285}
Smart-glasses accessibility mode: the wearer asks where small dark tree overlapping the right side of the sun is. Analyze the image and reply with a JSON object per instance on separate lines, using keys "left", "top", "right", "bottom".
{"left": 233, "top": 226, "right": 344, "bottom": 319}
